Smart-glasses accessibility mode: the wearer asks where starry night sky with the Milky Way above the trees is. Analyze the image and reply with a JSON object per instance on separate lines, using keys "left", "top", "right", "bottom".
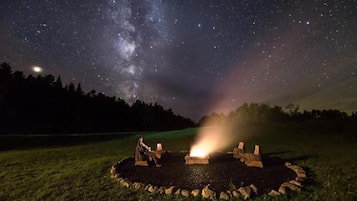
{"left": 0, "top": 0, "right": 357, "bottom": 120}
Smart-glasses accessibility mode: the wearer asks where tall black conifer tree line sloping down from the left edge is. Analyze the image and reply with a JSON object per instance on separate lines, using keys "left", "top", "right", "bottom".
{"left": 0, "top": 63, "right": 195, "bottom": 134}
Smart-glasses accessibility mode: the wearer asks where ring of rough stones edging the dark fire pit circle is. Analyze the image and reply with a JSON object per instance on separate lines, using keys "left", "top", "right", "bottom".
{"left": 110, "top": 155, "right": 307, "bottom": 200}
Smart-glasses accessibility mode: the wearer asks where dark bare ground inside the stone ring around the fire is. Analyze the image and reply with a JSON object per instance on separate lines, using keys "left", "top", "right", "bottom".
{"left": 115, "top": 153, "right": 296, "bottom": 194}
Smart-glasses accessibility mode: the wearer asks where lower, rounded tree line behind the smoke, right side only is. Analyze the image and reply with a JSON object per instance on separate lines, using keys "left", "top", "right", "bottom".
{"left": 199, "top": 103, "right": 357, "bottom": 135}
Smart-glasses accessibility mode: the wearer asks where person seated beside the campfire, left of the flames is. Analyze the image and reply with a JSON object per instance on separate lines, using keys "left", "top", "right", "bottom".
{"left": 135, "top": 136, "right": 161, "bottom": 167}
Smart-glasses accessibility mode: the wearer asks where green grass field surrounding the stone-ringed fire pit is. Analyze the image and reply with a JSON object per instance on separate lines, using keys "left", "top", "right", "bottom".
{"left": 0, "top": 127, "right": 357, "bottom": 201}
